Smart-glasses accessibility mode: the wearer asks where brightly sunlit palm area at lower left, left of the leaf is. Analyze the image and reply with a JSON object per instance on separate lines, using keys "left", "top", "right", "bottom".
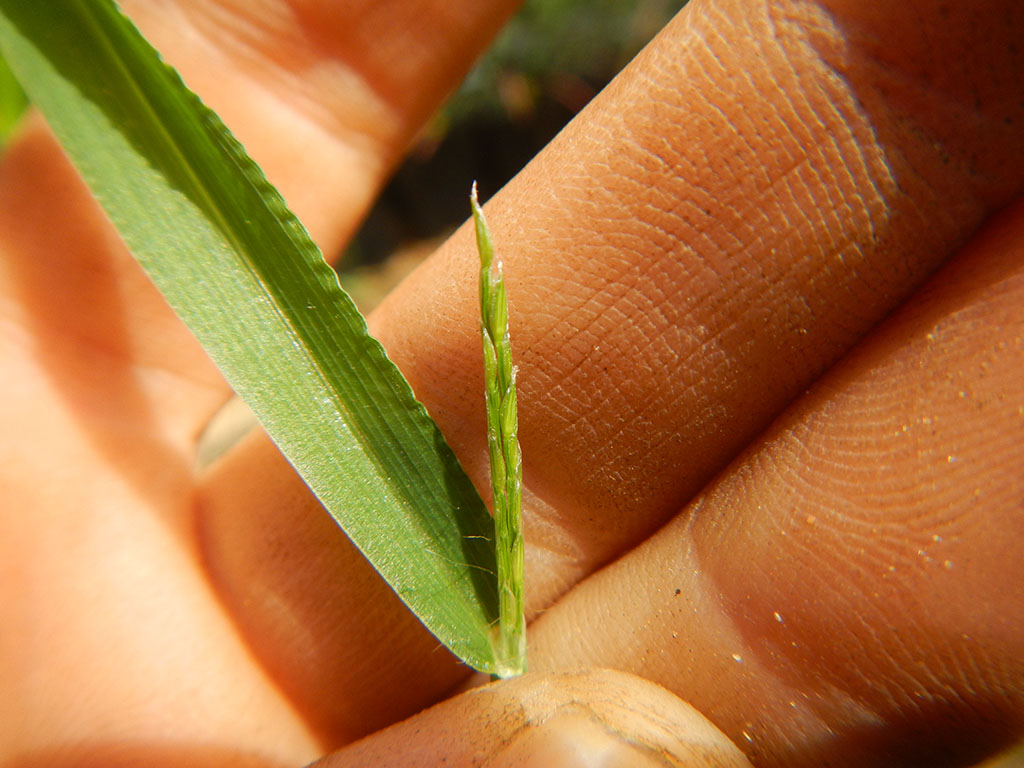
{"left": 0, "top": 126, "right": 318, "bottom": 766}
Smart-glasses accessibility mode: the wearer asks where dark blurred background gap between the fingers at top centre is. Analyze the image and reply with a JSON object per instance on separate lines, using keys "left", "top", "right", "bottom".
{"left": 340, "top": 0, "right": 686, "bottom": 271}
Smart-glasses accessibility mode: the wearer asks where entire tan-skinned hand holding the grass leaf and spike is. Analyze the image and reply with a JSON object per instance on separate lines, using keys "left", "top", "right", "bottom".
{"left": 0, "top": 0, "right": 1024, "bottom": 768}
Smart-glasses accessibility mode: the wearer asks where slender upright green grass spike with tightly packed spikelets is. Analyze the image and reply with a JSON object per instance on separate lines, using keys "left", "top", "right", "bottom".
{"left": 470, "top": 183, "right": 526, "bottom": 678}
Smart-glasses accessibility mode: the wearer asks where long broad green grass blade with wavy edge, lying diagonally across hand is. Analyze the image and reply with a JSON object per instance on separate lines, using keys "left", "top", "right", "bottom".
{"left": 0, "top": 0, "right": 498, "bottom": 672}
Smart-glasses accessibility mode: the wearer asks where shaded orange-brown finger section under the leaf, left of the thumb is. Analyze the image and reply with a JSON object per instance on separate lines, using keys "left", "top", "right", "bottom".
{"left": 198, "top": 431, "right": 467, "bottom": 746}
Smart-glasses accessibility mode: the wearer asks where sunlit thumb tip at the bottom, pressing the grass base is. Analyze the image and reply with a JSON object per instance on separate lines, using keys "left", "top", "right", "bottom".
{"left": 316, "top": 671, "right": 750, "bottom": 768}
